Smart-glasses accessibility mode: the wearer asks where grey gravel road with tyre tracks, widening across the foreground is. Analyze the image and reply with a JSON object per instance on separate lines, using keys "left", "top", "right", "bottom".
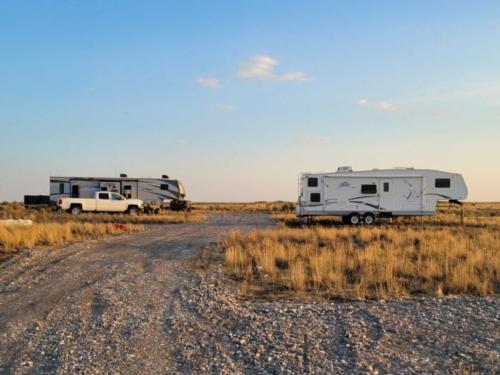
{"left": 0, "top": 214, "right": 500, "bottom": 374}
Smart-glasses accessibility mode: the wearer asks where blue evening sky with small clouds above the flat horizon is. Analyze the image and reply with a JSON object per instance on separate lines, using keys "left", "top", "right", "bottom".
{"left": 0, "top": 0, "right": 500, "bottom": 201}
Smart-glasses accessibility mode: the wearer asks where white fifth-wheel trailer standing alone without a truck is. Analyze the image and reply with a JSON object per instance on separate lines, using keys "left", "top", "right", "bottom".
{"left": 296, "top": 167, "right": 467, "bottom": 224}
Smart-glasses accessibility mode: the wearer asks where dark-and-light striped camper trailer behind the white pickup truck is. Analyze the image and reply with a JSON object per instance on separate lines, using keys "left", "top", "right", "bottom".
{"left": 50, "top": 174, "right": 188, "bottom": 210}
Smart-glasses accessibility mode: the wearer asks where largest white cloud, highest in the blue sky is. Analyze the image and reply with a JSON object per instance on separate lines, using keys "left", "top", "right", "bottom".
{"left": 236, "top": 55, "right": 312, "bottom": 82}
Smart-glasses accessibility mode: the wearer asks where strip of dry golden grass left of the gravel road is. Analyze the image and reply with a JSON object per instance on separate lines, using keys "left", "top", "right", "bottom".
{"left": 0, "top": 222, "right": 144, "bottom": 254}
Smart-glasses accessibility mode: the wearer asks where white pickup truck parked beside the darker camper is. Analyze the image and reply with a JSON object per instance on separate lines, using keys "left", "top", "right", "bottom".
{"left": 57, "top": 191, "right": 144, "bottom": 215}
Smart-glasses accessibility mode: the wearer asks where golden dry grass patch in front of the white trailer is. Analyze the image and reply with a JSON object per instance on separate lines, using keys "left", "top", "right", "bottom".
{"left": 222, "top": 203, "right": 500, "bottom": 298}
